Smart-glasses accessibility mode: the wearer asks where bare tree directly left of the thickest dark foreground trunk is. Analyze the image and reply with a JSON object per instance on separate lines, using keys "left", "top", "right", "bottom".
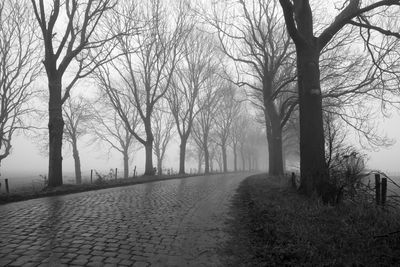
{"left": 211, "top": 0, "right": 297, "bottom": 175}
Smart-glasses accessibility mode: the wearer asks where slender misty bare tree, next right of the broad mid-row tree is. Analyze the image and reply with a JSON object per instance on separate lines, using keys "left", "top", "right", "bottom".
{"left": 167, "top": 29, "right": 216, "bottom": 174}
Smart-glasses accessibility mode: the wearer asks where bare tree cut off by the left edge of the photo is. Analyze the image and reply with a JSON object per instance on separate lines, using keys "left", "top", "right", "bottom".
{"left": 0, "top": 0, "right": 40, "bottom": 163}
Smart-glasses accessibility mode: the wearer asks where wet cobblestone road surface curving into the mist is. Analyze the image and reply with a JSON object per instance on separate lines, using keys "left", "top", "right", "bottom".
{"left": 0, "top": 174, "right": 246, "bottom": 266}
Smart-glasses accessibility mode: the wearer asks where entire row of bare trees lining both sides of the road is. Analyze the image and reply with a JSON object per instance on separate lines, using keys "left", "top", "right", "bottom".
{"left": 0, "top": 0, "right": 400, "bottom": 202}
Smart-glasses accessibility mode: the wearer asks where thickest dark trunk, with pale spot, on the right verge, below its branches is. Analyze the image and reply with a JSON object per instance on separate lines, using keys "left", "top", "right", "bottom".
{"left": 296, "top": 40, "right": 327, "bottom": 196}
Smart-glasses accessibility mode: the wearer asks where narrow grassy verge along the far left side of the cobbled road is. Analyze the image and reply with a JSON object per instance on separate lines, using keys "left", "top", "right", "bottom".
{"left": 0, "top": 173, "right": 234, "bottom": 205}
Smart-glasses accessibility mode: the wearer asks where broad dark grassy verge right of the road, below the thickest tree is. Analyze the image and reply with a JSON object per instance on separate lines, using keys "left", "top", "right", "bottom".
{"left": 225, "top": 174, "right": 400, "bottom": 266}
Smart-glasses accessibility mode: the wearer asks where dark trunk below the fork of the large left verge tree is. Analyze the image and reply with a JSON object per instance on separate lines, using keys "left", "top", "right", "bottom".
{"left": 48, "top": 78, "right": 64, "bottom": 187}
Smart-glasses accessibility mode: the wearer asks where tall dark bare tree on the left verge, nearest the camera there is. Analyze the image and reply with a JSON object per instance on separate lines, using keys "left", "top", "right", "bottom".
{"left": 31, "top": 0, "right": 120, "bottom": 187}
